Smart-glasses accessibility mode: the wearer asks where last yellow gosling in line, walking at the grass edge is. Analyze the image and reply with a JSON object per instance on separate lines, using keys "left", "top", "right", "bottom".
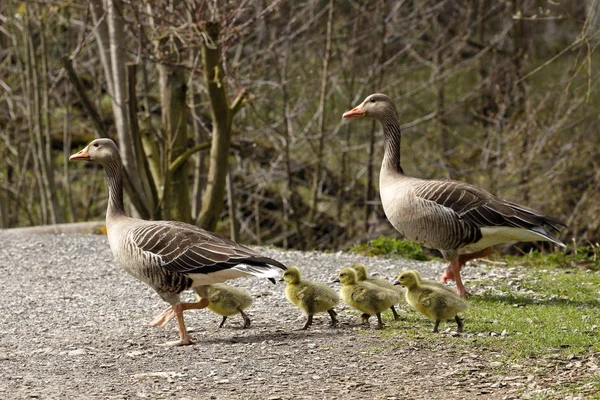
{"left": 394, "top": 270, "right": 467, "bottom": 333}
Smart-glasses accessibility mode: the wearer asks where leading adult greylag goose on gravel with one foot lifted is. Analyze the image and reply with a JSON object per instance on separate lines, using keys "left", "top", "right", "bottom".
{"left": 69, "top": 139, "right": 286, "bottom": 345}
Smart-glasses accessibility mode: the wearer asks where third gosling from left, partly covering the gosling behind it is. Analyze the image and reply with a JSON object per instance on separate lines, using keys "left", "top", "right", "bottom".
{"left": 337, "top": 268, "right": 398, "bottom": 329}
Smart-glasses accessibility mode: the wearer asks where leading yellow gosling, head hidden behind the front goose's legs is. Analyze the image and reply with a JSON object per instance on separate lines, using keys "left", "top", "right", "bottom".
{"left": 194, "top": 284, "right": 252, "bottom": 329}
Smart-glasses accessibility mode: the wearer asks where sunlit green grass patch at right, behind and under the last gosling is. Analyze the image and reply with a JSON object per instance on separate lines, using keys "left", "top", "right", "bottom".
{"left": 360, "top": 260, "right": 600, "bottom": 362}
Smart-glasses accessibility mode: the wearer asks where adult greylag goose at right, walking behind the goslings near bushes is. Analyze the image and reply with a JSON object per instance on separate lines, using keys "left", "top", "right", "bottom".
{"left": 343, "top": 93, "right": 566, "bottom": 297}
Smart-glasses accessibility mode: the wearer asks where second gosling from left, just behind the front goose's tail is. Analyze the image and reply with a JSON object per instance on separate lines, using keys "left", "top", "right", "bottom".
{"left": 283, "top": 266, "right": 340, "bottom": 330}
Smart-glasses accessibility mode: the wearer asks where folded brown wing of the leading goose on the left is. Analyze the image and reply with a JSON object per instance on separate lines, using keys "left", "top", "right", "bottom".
{"left": 128, "top": 221, "right": 286, "bottom": 275}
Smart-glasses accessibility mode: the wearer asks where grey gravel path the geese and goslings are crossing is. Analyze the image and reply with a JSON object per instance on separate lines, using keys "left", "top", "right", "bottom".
{"left": 0, "top": 232, "right": 596, "bottom": 400}
